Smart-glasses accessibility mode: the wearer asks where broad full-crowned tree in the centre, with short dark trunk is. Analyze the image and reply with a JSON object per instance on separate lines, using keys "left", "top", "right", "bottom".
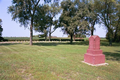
{"left": 59, "top": 0, "right": 89, "bottom": 43}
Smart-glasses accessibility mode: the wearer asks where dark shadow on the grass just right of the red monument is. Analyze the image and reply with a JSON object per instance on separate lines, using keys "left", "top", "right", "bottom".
{"left": 103, "top": 51, "right": 120, "bottom": 61}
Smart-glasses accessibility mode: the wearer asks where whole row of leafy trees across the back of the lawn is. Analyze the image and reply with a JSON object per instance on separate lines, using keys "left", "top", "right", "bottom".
{"left": 8, "top": 0, "right": 120, "bottom": 45}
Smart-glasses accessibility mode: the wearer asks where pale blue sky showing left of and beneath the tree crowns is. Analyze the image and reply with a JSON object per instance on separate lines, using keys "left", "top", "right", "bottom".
{"left": 0, "top": 0, "right": 106, "bottom": 37}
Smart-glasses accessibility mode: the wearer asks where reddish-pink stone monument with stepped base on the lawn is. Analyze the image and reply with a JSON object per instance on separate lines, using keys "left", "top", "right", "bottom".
{"left": 84, "top": 36, "right": 105, "bottom": 65}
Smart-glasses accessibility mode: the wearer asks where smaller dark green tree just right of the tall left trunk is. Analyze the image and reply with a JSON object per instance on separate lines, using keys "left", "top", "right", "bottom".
{"left": 34, "top": 5, "right": 51, "bottom": 40}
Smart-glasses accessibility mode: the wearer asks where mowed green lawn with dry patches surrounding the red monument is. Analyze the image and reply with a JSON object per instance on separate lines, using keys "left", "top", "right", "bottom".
{"left": 0, "top": 42, "right": 120, "bottom": 80}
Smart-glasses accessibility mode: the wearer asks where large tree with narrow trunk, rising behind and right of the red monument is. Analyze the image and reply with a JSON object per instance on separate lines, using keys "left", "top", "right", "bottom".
{"left": 94, "top": 0, "right": 118, "bottom": 45}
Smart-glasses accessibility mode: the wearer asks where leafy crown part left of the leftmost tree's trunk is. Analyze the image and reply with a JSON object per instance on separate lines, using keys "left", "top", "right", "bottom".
{"left": 8, "top": 0, "right": 31, "bottom": 27}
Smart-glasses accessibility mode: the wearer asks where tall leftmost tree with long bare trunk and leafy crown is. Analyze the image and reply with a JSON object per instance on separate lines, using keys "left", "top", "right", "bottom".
{"left": 8, "top": 0, "right": 51, "bottom": 45}
